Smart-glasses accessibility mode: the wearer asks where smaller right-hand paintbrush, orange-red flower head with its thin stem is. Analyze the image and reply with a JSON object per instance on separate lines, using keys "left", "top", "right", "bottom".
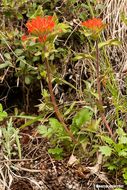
{"left": 81, "top": 18, "right": 113, "bottom": 136}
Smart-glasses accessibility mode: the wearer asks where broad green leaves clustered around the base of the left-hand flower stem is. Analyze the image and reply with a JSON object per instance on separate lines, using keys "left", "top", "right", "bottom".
{"left": 38, "top": 107, "right": 97, "bottom": 158}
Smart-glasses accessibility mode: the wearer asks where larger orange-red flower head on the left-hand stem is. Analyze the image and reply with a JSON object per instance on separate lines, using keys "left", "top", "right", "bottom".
{"left": 26, "top": 16, "right": 55, "bottom": 42}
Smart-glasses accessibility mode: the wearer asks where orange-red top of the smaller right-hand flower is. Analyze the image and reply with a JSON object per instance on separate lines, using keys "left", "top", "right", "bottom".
{"left": 81, "top": 18, "right": 104, "bottom": 31}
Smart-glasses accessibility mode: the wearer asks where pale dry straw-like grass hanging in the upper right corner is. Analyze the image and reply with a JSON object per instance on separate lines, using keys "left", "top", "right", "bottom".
{"left": 101, "top": 0, "right": 127, "bottom": 71}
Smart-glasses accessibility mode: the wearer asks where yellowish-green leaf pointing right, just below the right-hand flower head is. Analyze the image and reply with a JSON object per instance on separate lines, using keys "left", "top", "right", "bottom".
{"left": 98, "top": 39, "right": 122, "bottom": 49}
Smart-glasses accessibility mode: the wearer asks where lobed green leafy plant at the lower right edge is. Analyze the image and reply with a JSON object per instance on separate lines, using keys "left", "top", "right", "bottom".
{"left": 99, "top": 128, "right": 127, "bottom": 184}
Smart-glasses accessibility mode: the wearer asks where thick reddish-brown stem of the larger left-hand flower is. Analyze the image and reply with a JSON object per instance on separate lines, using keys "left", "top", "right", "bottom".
{"left": 45, "top": 58, "right": 77, "bottom": 144}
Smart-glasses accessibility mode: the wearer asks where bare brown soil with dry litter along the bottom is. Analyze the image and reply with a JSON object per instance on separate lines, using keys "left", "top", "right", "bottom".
{"left": 1, "top": 132, "right": 121, "bottom": 190}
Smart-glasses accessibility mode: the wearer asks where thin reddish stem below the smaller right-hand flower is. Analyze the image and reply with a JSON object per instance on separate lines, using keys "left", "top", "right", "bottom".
{"left": 96, "top": 40, "right": 113, "bottom": 136}
